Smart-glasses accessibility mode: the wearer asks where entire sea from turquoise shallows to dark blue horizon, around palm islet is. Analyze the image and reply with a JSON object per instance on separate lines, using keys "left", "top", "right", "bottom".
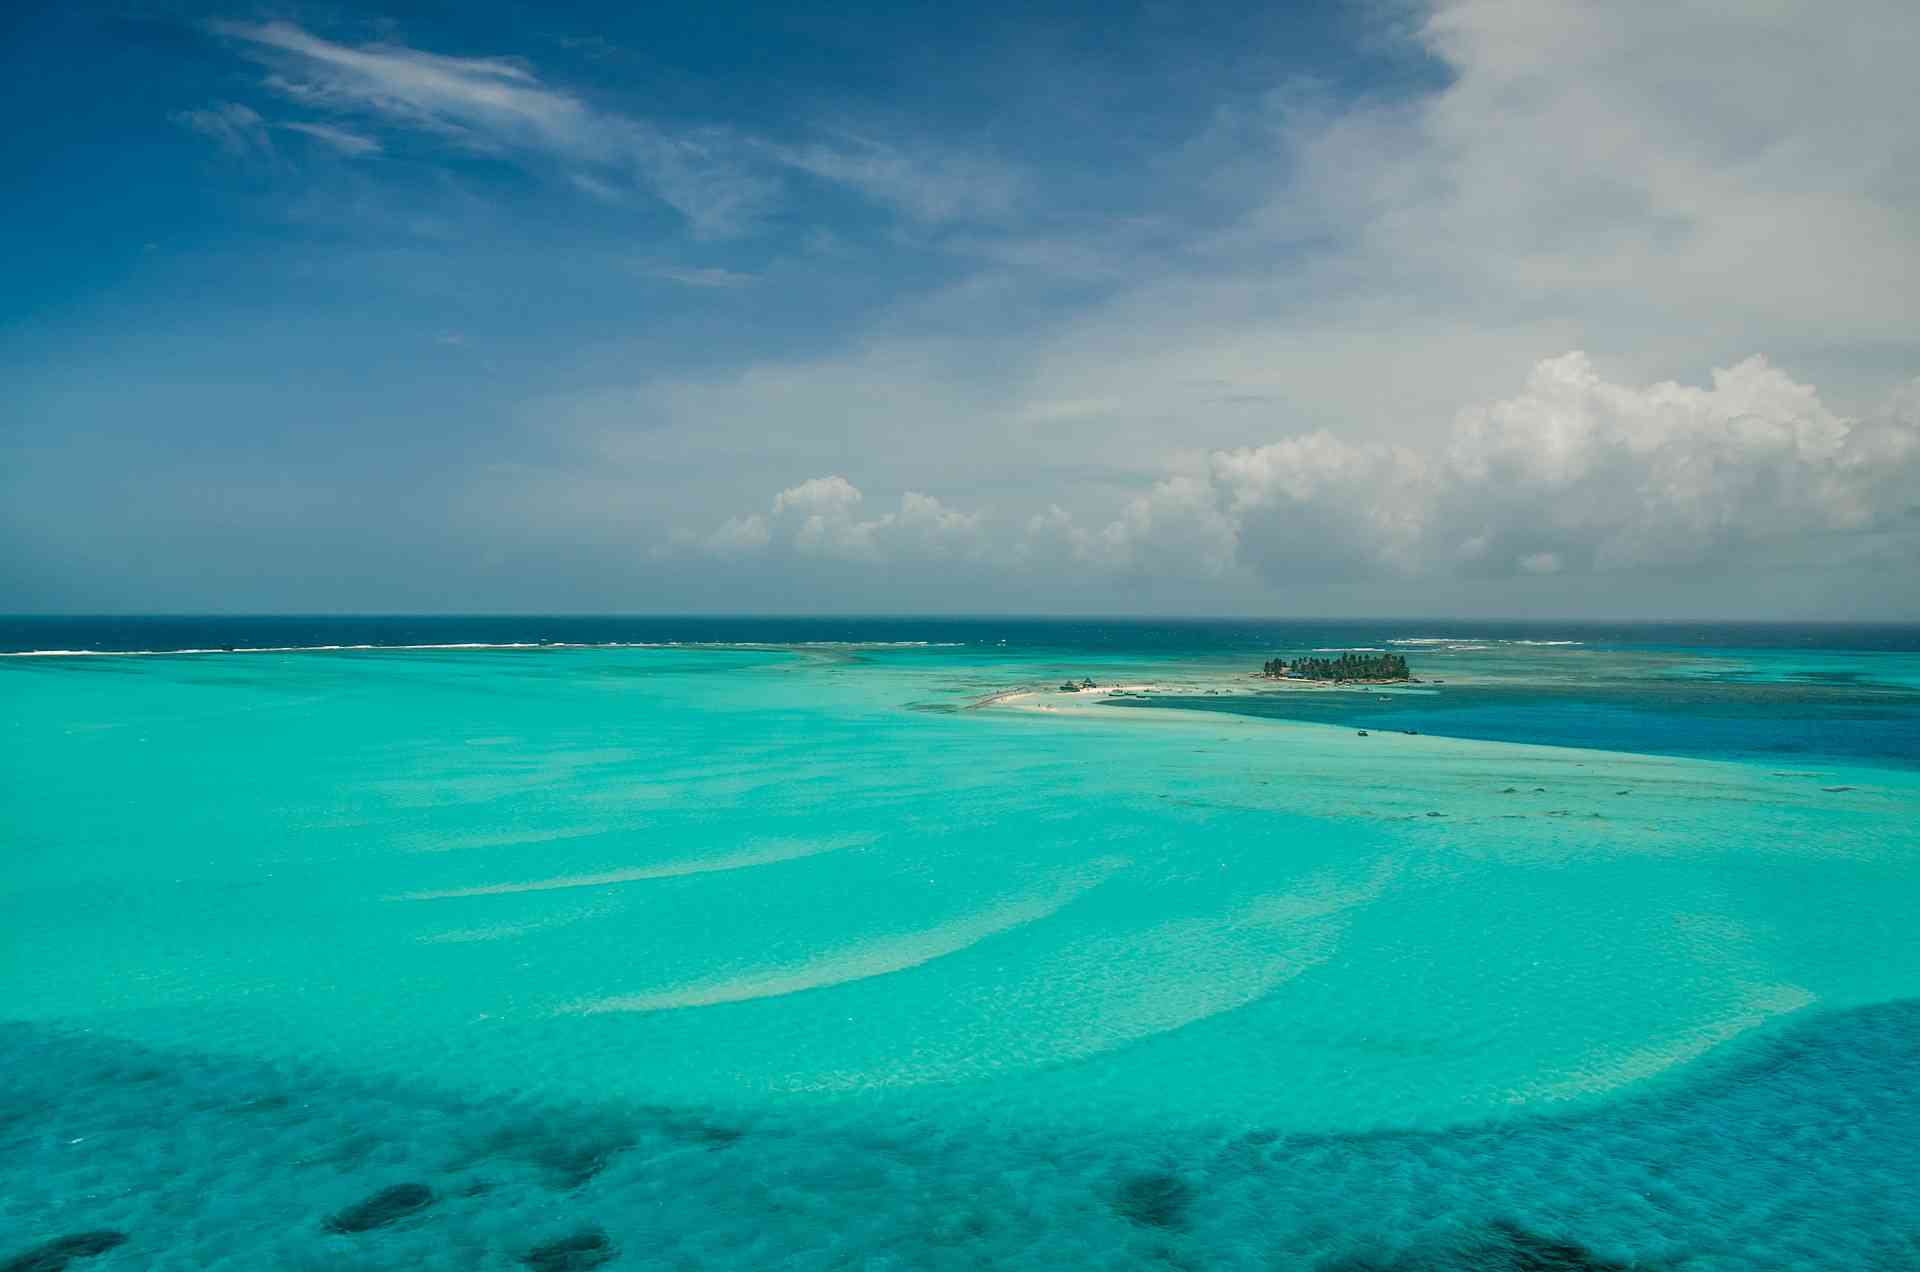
{"left": 0, "top": 619, "right": 1920, "bottom": 1270}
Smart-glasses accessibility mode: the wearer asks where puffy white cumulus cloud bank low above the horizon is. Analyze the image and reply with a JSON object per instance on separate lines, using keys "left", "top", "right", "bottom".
{"left": 674, "top": 354, "right": 1920, "bottom": 584}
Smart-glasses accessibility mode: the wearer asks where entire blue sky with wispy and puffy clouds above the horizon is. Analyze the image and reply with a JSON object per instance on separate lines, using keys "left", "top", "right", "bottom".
{"left": 0, "top": 0, "right": 1920, "bottom": 619}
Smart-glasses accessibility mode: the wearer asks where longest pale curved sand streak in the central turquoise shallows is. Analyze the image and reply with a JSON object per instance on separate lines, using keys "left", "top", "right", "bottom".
{"left": 555, "top": 859, "right": 1125, "bottom": 1016}
